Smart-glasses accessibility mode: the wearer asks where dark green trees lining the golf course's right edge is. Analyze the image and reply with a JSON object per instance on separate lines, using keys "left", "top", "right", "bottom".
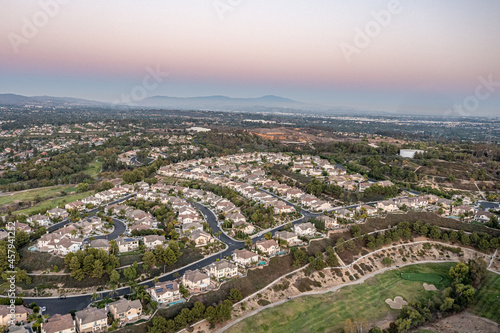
{"left": 369, "top": 259, "right": 487, "bottom": 333}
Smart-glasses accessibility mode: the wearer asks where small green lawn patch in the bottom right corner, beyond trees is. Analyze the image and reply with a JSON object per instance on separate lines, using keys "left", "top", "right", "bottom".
{"left": 470, "top": 272, "right": 500, "bottom": 323}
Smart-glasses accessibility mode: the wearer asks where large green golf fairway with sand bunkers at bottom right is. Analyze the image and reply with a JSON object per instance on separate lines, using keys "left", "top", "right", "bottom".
{"left": 227, "top": 263, "right": 454, "bottom": 333}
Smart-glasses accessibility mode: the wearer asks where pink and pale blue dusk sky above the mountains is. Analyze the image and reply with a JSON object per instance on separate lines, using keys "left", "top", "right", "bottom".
{"left": 0, "top": 0, "right": 500, "bottom": 115}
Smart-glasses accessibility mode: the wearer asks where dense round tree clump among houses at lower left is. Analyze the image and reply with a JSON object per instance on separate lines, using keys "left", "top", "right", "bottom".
{"left": 64, "top": 248, "right": 120, "bottom": 281}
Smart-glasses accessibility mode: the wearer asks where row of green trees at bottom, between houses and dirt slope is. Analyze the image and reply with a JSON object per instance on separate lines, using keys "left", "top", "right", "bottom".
{"left": 148, "top": 289, "right": 241, "bottom": 333}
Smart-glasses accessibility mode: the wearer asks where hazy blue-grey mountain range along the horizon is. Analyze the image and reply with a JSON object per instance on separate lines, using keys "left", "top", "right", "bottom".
{"left": 0, "top": 94, "right": 372, "bottom": 114}
